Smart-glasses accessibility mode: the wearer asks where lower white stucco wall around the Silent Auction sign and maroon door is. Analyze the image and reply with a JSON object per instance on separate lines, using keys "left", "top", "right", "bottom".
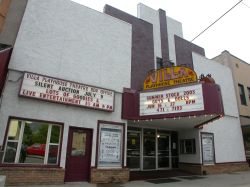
{"left": 0, "top": 71, "right": 126, "bottom": 168}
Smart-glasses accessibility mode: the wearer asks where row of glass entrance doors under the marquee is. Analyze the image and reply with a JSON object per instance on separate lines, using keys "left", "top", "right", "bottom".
{"left": 127, "top": 127, "right": 177, "bottom": 171}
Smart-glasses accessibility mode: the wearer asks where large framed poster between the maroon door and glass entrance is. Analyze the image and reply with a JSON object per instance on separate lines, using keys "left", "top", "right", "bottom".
{"left": 97, "top": 121, "right": 124, "bottom": 168}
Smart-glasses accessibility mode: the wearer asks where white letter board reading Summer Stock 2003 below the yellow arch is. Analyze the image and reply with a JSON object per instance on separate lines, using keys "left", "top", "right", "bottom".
{"left": 140, "top": 84, "right": 204, "bottom": 116}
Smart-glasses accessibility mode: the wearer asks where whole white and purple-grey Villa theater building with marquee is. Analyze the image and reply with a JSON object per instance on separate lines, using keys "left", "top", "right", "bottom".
{"left": 0, "top": 0, "right": 248, "bottom": 185}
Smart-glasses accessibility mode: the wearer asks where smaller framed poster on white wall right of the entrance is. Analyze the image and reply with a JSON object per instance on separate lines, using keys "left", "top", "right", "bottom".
{"left": 201, "top": 133, "right": 215, "bottom": 165}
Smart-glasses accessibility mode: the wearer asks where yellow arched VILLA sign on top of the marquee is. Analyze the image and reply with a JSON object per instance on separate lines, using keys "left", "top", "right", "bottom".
{"left": 143, "top": 66, "right": 197, "bottom": 90}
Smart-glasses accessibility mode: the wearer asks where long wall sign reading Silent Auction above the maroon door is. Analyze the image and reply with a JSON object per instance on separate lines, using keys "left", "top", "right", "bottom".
{"left": 19, "top": 72, "right": 114, "bottom": 112}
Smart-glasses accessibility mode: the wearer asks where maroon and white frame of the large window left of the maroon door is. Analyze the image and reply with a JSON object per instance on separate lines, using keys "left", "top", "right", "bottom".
{"left": 0, "top": 116, "right": 64, "bottom": 168}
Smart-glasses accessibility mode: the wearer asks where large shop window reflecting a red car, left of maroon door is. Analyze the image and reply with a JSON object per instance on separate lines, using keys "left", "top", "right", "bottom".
{"left": 2, "top": 119, "right": 62, "bottom": 165}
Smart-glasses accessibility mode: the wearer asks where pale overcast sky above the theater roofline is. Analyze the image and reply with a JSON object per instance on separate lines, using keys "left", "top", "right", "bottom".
{"left": 73, "top": 0, "right": 250, "bottom": 64}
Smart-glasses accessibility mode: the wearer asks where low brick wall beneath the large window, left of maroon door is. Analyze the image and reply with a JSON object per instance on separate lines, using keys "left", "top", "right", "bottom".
{"left": 0, "top": 167, "right": 65, "bottom": 186}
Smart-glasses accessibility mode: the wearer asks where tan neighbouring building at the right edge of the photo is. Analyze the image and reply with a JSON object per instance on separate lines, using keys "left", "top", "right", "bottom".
{"left": 214, "top": 51, "right": 250, "bottom": 162}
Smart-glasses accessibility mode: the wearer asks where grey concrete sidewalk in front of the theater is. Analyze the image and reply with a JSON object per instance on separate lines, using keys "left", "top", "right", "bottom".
{"left": 8, "top": 171, "right": 250, "bottom": 187}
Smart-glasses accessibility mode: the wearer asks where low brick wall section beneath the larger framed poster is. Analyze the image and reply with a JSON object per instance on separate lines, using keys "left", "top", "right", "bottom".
{"left": 91, "top": 168, "right": 129, "bottom": 183}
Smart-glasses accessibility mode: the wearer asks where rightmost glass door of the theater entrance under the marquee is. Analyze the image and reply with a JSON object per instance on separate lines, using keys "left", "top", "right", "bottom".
{"left": 157, "top": 131, "right": 171, "bottom": 169}
